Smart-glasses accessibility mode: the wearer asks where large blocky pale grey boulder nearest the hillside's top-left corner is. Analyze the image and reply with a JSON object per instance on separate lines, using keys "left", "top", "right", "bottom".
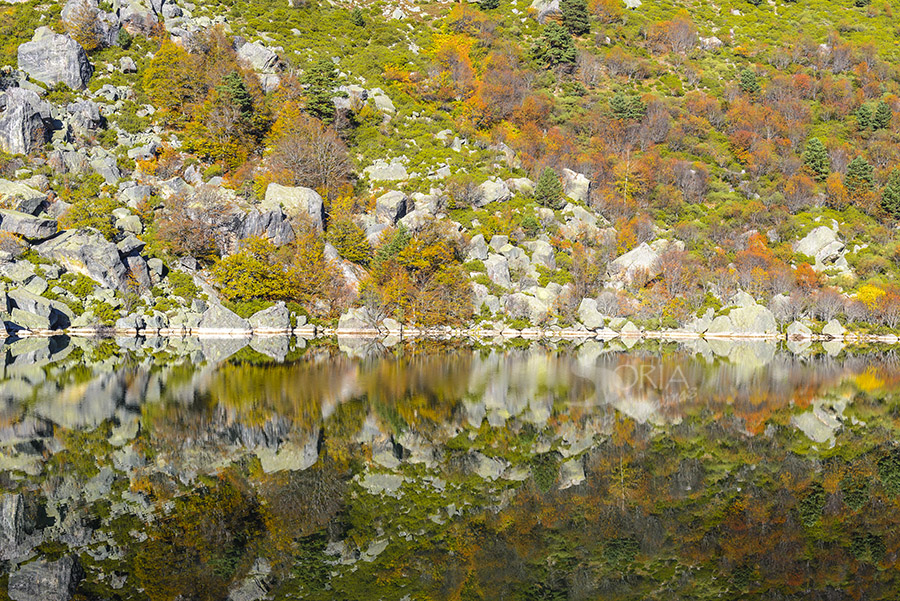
{"left": 18, "top": 27, "right": 94, "bottom": 90}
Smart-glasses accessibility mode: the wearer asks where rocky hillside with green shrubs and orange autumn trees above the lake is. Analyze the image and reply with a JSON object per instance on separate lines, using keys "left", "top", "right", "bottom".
{"left": 0, "top": 0, "right": 900, "bottom": 339}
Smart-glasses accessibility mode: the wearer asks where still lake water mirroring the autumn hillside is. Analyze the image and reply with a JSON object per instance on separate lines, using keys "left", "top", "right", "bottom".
{"left": 0, "top": 338, "right": 900, "bottom": 601}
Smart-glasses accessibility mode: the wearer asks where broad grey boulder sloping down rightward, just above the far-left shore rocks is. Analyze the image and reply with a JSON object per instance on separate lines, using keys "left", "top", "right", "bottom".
{"left": 34, "top": 229, "right": 128, "bottom": 291}
